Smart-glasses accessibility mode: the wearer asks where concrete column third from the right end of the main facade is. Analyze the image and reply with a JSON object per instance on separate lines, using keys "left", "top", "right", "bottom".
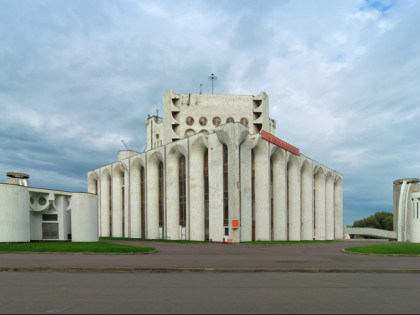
{"left": 315, "top": 169, "right": 325, "bottom": 240}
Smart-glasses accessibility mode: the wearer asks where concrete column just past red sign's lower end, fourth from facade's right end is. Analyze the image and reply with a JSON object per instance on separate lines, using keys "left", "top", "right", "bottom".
{"left": 301, "top": 161, "right": 314, "bottom": 240}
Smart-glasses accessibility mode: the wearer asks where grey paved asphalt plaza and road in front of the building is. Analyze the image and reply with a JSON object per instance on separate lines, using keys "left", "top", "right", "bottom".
{"left": 0, "top": 241, "right": 420, "bottom": 314}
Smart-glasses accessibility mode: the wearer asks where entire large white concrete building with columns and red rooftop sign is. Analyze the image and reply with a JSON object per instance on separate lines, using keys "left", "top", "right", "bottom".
{"left": 88, "top": 91, "right": 343, "bottom": 243}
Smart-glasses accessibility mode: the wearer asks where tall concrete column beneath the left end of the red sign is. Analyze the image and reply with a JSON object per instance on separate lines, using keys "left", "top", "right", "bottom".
{"left": 254, "top": 139, "right": 271, "bottom": 241}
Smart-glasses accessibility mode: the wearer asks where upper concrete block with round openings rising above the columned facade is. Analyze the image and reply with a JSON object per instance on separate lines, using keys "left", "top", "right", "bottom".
{"left": 162, "top": 91, "right": 275, "bottom": 150}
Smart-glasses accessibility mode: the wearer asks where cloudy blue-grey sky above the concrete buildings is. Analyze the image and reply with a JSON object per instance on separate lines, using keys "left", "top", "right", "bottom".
{"left": 0, "top": 0, "right": 420, "bottom": 225}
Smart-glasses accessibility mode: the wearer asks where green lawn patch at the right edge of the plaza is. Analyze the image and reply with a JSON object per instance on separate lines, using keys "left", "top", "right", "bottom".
{"left": 346, "top": 243, "right": 420, "bottom": 255}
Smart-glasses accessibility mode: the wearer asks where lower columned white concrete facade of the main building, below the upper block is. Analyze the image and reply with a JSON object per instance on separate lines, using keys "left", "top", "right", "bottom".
{"left": 92, "top": 123, "right": 343, "bottom": 242}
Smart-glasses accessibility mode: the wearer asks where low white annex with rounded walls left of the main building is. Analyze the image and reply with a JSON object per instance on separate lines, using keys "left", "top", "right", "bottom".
{"left": 0, "top": 173, "right": 98, "bottom": 243}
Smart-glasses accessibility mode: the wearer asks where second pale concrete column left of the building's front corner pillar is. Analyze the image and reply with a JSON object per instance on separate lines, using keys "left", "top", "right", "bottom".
{"left": 189, "top": 142, "right": 205, "bottom": 241}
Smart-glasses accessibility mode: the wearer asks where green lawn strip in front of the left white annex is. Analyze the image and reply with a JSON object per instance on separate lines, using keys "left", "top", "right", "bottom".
{"left": 0, "top": 242, "right": 155, "bottom": 254}
